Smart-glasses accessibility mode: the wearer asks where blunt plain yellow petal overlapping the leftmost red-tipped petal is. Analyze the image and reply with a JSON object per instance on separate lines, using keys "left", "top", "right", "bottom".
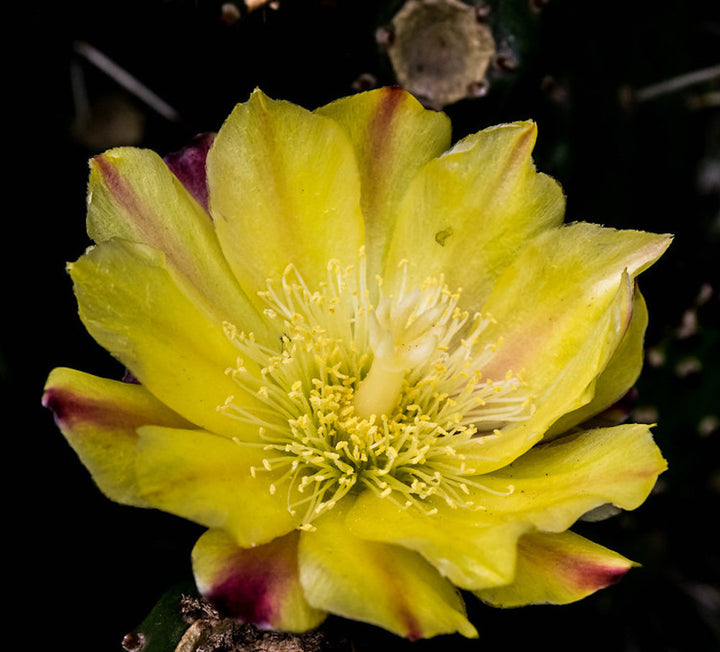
{"left": 136, "top": 426, "right": 300, "bottom": 547}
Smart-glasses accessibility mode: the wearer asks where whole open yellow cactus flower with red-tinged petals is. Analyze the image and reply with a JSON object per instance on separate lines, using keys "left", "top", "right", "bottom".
{"left": 44, "top": 88, "right": 670, "bottom": 639}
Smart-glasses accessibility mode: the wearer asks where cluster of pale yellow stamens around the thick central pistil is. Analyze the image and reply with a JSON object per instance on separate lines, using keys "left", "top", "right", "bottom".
{"left": 218, "top": 252, "right": 532, "bottom": 527}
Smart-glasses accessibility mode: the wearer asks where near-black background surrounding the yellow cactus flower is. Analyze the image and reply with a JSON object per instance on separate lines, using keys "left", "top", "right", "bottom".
{"left": 8, "top": 0, "right": 720, "bottom": 652}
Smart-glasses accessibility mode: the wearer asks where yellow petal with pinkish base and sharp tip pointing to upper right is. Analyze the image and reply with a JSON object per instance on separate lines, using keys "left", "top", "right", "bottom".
{"left": 483, "top": 223, "right": 670, "bottom": 392}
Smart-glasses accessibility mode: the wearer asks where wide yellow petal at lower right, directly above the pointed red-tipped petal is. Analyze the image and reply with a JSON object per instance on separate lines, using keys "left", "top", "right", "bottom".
{"left": 468, "top": 424, "right": 667, "bottom": 532}
